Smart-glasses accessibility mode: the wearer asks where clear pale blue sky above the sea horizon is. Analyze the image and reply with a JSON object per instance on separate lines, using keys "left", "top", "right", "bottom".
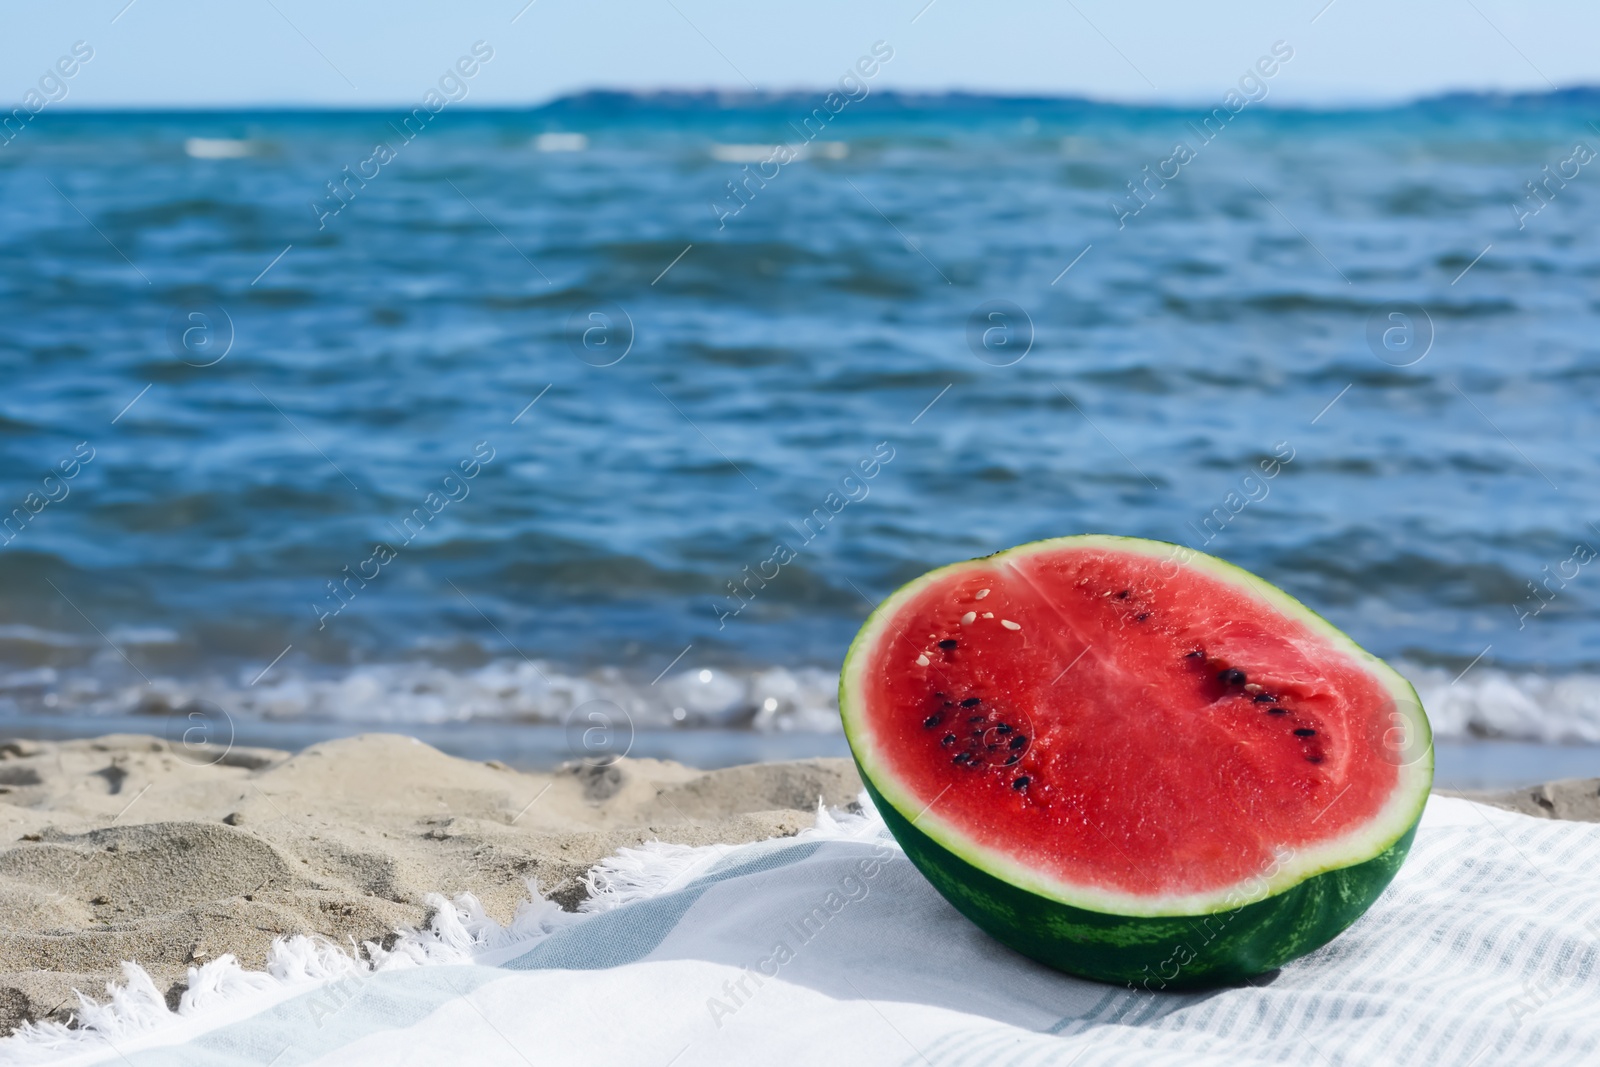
{"left": 0, "top": 0, "right": 1600, "bottom": 109}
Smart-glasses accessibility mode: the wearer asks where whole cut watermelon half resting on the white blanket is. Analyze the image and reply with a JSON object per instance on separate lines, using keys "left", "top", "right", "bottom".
{"left": 838, "top": 536, "right": 1434, "bottom": 990}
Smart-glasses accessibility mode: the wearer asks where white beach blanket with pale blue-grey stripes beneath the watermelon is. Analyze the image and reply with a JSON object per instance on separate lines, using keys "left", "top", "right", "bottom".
{"left": 0, "top": 797, "right": 1600, "bottom": 1067}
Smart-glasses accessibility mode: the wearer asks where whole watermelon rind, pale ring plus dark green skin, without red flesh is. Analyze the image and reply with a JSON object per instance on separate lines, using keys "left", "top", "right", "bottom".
{"left": 838, "top": 534, "right": 1434, "bottom": 987}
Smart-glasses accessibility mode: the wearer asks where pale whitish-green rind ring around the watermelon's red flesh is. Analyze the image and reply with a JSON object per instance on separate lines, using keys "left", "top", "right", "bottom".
{"left": 838, "top": 534, "right": 1434, "bottom": 917}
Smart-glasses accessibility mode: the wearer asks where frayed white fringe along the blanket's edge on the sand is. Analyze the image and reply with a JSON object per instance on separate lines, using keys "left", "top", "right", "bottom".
{"left": 0, "top": 793, "right": 886, "bottom": 1067}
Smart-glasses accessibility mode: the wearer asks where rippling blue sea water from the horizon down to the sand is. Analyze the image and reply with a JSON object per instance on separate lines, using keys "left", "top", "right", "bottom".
{"left": 0, "top": 93, "right": 1600, "bottom": 782}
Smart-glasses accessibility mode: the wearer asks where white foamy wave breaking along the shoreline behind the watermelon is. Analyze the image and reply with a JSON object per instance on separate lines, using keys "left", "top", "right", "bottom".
{"left": 0, "top": 659, "right": 1600, "bottom": 744}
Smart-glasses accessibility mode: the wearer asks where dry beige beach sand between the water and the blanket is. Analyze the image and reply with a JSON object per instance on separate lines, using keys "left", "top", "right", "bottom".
{"left": 0, "top": 734, "right": 1600, "bottom": 1033}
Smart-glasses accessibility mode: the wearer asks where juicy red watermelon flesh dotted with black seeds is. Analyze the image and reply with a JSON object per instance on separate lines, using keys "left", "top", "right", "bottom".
{"left": 853, "top": 539, "right": 1426, "bottom": 899}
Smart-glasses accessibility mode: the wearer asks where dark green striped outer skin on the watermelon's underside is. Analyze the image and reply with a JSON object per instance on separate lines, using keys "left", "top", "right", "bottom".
{"left": 862, "top": 773, "right": 1416, "bottom": 990}
